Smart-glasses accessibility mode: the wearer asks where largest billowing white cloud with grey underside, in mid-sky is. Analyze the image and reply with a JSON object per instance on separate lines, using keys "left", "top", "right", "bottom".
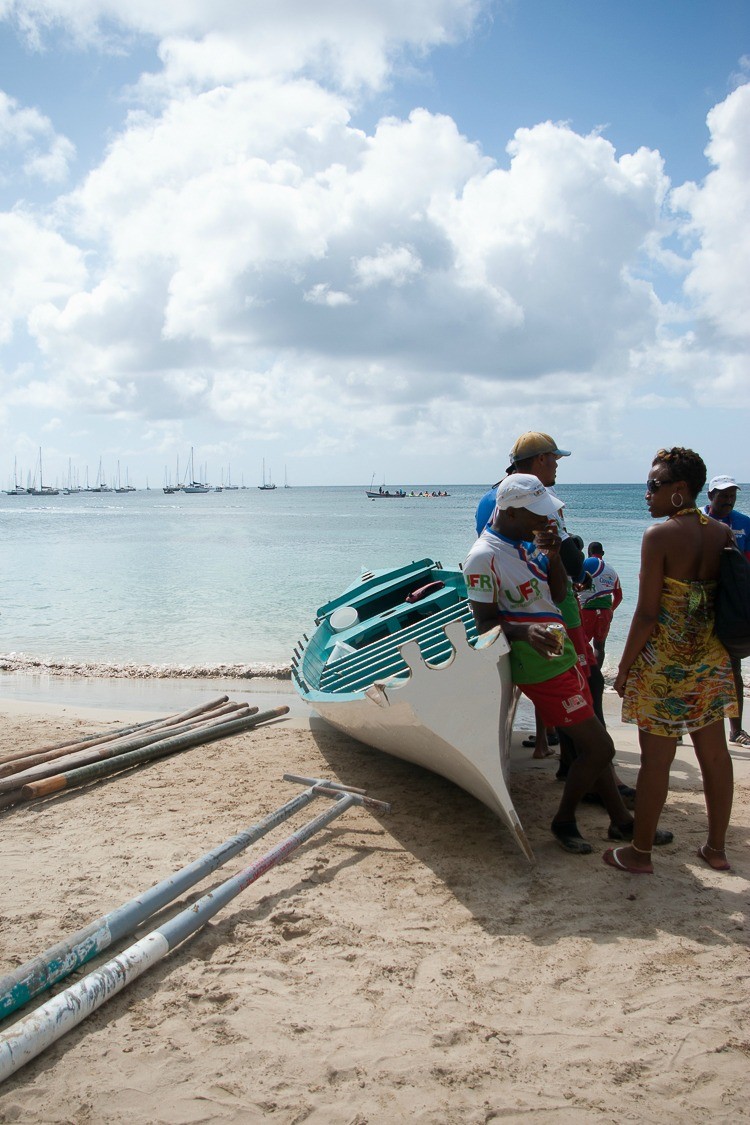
{"left": 20, "top": 90, "right": 667, "bottom": 425}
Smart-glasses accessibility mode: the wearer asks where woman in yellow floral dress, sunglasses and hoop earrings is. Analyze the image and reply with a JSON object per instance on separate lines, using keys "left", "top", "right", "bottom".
{"left": 604, "top": 448, "right": 737, "bottom": 874}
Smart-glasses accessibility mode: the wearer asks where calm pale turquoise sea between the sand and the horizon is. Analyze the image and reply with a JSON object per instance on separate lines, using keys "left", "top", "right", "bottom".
{"left": 0, "top": 484, "right": 715, "bottom": 675}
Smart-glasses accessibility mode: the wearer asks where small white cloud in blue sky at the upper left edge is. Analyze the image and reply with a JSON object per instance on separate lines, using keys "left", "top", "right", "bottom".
{"left": 0, "top": 90, "right": 75, "bottom": 183}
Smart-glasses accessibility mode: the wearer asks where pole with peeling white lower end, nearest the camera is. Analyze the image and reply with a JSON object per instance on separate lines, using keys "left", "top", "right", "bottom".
{"left": 0, "top": 793, "right": 386, "bottom": 1082}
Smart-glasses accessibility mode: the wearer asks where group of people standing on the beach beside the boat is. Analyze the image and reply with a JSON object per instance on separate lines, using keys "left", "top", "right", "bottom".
{"left": 463, "top": 431, "right": 750, "bottom": 874}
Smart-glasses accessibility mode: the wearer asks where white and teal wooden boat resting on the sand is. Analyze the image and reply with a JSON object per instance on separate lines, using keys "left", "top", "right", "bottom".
{"left": 292, "top": 558, "right": 533, "bottom": 860}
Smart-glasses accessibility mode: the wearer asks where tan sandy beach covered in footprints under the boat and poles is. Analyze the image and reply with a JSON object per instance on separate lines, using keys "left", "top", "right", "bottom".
{"left": 0, "top": 683, "right": 750, "bottom": 1125}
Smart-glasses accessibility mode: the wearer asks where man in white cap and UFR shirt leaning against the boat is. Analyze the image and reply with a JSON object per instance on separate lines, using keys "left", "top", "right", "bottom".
{"left": 463, "top": 473, "right": 671, "bottom": 855}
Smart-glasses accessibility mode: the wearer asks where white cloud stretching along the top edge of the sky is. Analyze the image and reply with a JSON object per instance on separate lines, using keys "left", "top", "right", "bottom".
{"left": 0, "top": 0, "right": 488, "bottom": 89}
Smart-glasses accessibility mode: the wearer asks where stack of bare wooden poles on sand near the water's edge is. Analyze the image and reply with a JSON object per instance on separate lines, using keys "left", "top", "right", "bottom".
{"left": 0, "top": 695, "right": 289, "bottom": 809}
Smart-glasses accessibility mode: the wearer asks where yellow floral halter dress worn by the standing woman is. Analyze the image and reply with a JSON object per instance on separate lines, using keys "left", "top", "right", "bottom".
{"left": 623, "top": 578, "right": 738, "bottom": 738}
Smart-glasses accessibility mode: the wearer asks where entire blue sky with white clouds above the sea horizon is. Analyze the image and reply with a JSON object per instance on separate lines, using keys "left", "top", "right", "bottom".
{"left": 0, "top": 0, "right": 750, "bottom": 492}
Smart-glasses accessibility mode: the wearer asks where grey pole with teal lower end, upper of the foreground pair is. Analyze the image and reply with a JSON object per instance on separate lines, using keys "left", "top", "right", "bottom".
{"left": 0, "top": 783, "right": 334, "bottom": 1019}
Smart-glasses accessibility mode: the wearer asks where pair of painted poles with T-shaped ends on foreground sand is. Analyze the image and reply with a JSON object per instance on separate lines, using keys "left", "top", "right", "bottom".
{"left": 0, "top": 775, "right": 390, "bottom": 1083}
